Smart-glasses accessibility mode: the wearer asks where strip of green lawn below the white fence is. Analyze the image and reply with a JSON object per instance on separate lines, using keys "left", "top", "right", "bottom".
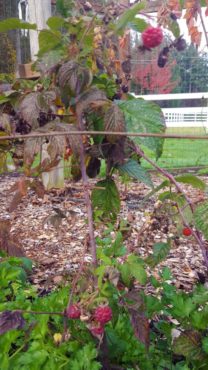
{"left": 144, "top": 128, "right": 208, "bottom": 168}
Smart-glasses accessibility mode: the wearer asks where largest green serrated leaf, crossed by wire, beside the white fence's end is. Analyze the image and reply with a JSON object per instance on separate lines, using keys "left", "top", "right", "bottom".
{"left": 117, "top": 99, "right": 165, "bottom": 159}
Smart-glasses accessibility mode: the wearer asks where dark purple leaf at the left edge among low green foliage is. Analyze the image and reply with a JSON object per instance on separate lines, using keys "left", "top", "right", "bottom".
{"left": 0, "top": 311, "right": 25, "bottom": 335}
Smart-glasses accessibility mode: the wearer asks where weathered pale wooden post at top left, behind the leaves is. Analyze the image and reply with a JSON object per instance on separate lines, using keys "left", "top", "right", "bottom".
{"left": 28, "top": 0, "right": 51, "bottom": 61}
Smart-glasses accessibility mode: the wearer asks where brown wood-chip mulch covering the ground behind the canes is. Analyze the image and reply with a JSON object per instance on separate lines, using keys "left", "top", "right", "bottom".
{"left": 0, "top": 175, "right": 208, "bottom": 291}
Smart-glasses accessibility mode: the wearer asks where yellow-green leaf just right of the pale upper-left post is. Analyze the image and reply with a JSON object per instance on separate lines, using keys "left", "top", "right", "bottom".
{"left": 38, "top": 30, "right": 62, "bottom": 56}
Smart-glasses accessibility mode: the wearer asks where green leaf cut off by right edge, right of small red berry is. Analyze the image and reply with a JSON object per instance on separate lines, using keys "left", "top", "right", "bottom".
{"left": 194, "top": 201, "right": 208, "bottom": 239}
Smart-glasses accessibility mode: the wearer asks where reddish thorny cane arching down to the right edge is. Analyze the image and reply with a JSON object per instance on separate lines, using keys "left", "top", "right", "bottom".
{"left": 134, "top": 146, "right": 208, "bottom": 269}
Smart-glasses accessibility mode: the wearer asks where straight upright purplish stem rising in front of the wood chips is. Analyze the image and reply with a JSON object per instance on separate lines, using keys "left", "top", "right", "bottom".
{"left": 77, "top": 112, "right": 97, "bottom": 267}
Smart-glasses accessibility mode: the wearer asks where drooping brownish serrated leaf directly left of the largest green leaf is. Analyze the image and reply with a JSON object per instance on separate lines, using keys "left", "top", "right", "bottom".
{"left": 104, "top": 104, "right": 126, "bottom": 144}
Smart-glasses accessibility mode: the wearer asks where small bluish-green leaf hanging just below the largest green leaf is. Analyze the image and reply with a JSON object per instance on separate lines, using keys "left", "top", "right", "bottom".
{"left": 117, "top": 159, "right": 153, "bottom": 188}
